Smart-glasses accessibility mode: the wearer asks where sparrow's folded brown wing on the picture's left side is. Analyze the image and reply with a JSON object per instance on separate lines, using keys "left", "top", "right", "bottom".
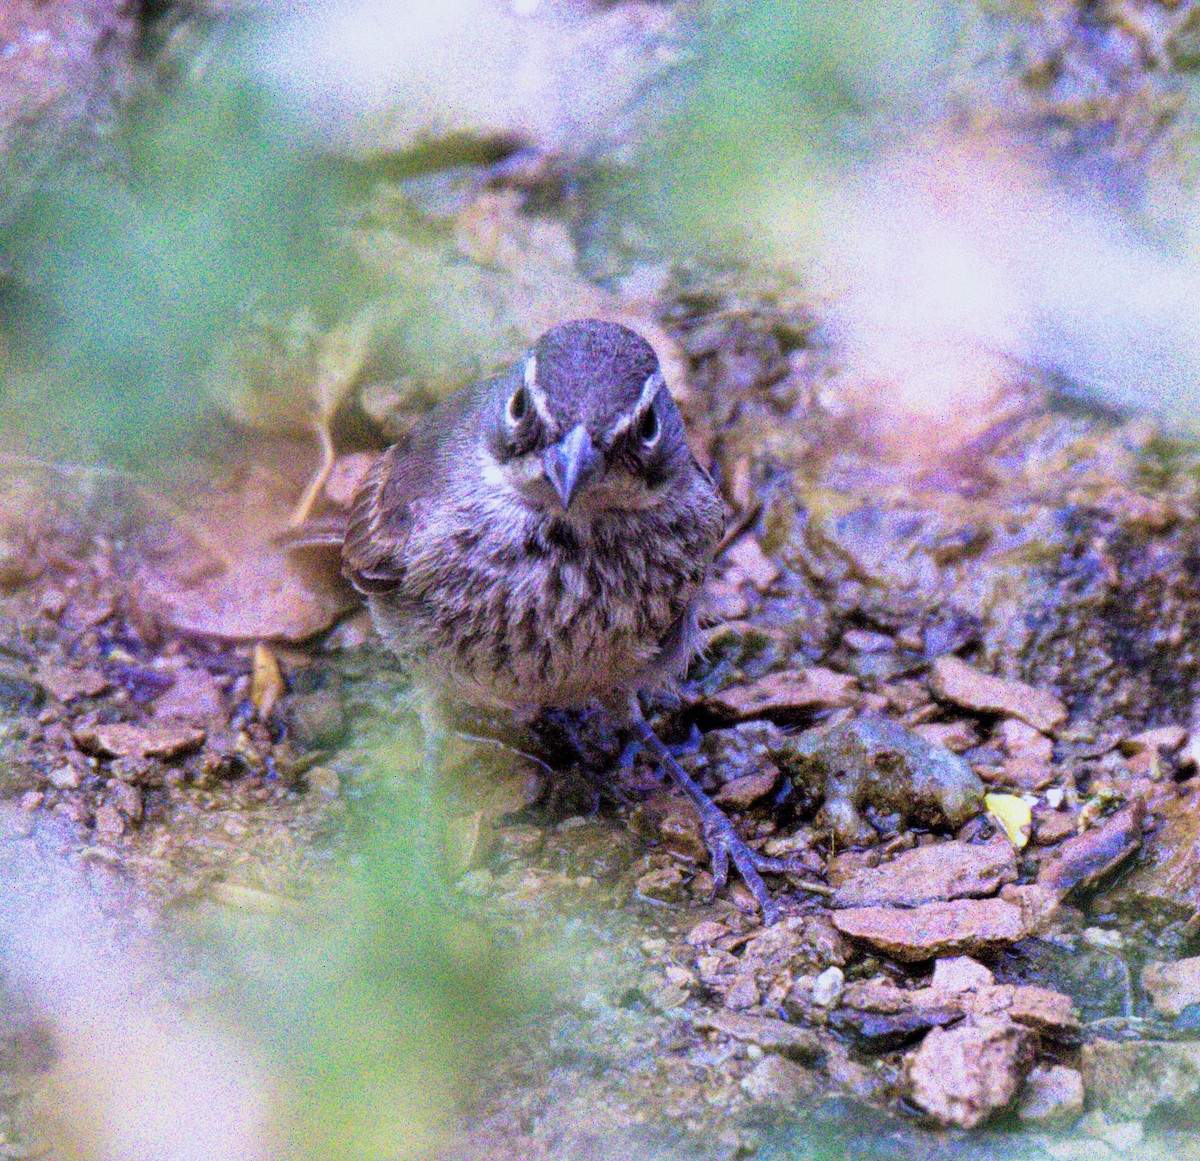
{"left": 342, "top": 392, "right": 475, "bottom": 594}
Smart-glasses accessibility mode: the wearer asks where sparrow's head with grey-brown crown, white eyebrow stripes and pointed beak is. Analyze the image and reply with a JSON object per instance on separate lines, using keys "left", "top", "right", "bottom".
{"left": 485, "top": 319, "right": 691, "bottom": 515}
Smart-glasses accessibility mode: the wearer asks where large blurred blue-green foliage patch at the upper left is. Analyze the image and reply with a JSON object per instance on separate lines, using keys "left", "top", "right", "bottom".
{"left": 2, "top": 17, "right": 355, "bottom": 463}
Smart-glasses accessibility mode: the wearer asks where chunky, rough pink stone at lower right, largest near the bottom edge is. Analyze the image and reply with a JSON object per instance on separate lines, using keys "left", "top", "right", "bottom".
{"left": 904, "top": 1016, "right": 1033, "bottom": 1129}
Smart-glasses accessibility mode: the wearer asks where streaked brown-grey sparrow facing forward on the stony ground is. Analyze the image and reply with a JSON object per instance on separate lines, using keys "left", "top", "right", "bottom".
{"left": 324, "top": 319, "right": 800, "bottom": 920}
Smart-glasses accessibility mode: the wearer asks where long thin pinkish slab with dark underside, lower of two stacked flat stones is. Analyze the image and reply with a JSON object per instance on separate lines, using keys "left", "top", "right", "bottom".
{"left": 832, "top": 898, "right": 1028, "bottom": 962}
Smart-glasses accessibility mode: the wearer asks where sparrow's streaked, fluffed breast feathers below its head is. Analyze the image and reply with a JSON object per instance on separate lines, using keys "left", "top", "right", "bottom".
{"left": 377, "top": 496, "right": 712, "bottom": 705}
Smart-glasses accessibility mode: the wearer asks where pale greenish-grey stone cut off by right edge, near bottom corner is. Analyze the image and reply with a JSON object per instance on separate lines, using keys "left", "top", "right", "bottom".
{"left": 1080, "top": 1040, "right": 1200, "bottom": 1120}
